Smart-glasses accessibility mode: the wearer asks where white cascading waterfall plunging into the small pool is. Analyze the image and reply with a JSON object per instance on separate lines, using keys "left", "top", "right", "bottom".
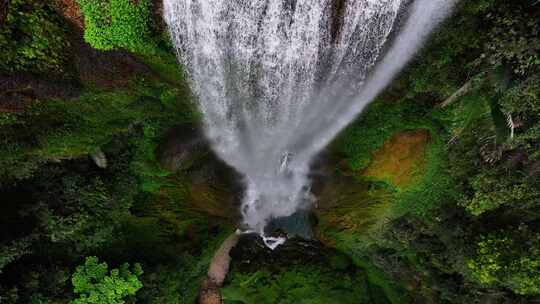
{"left": 164, "top": 0, "right": 456, "bottom": 247}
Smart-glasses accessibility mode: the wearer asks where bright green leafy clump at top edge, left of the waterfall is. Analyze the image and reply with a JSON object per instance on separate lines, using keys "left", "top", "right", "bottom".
{"left": 78, "top": 0, "right": 155, "bottom": 53}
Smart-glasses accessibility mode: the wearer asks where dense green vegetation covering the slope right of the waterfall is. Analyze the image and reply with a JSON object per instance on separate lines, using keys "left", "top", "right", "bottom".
{"left": 326, "top": 1, "right": 540, "bottom": 303}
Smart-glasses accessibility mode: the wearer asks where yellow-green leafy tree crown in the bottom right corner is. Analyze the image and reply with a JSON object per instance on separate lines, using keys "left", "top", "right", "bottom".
{"left": 467, "top": 228, "right": 540, "bottom": 295}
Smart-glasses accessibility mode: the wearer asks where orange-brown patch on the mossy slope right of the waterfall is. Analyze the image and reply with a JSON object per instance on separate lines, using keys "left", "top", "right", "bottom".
{"left": 362, "top": 130, "right": 430, "bottom": 188}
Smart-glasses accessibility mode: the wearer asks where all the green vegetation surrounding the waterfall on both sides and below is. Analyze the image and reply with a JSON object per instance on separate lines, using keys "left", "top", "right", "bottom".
{"left": 0, "top": 0, "right": 540, "bottom": 304}
